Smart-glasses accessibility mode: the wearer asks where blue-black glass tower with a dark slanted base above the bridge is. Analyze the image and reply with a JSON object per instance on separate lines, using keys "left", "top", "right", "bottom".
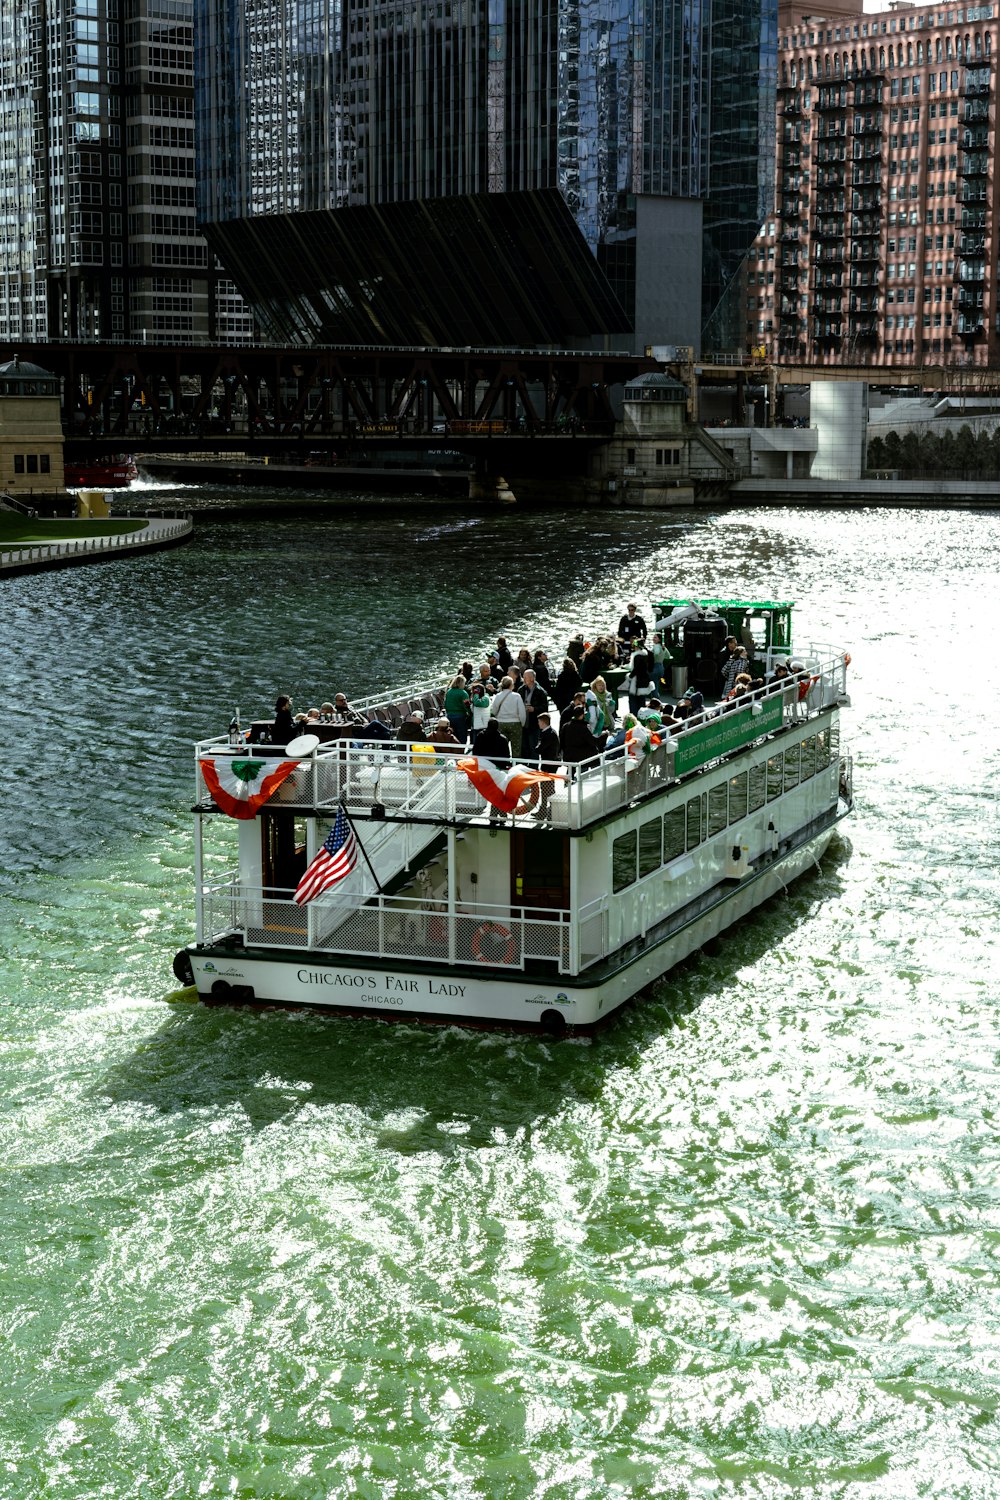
{"left": 196, "top": 0, "right": 708, "bottom": 344}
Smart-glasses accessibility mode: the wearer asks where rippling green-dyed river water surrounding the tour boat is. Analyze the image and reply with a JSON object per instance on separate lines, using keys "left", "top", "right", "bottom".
{"left": 0, "top": 495, "right": 1000, "bottom": 1500}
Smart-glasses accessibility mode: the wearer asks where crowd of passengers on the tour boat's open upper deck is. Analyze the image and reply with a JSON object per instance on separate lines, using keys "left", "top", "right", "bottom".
{"left": 271, "top": 605, "right": 808, "bottom": 768}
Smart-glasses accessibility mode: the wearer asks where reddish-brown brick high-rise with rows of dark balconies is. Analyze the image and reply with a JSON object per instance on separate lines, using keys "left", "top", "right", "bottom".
{"left": 745, "top": 3, "right": 1000, "bottom": 366}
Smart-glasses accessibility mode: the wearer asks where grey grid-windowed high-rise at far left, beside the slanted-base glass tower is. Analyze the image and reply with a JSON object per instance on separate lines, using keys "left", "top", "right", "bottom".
{"left": 0, "top": 0, "right": 252, "bottom": 344}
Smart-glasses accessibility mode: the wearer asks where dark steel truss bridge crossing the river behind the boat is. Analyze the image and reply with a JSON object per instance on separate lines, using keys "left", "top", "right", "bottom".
{"left": 0, "top": 341, "right": 658, "bottom": 450}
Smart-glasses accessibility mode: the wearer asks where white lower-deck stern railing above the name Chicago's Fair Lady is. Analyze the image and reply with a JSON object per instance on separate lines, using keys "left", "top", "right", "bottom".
{"left": 201, "top": 879, "right": 581, "bottom": 974}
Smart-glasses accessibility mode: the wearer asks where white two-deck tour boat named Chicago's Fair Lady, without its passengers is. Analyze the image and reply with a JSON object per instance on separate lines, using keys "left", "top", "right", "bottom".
{"left": 174, "top": 600, "right": 853, "bottom": 1034}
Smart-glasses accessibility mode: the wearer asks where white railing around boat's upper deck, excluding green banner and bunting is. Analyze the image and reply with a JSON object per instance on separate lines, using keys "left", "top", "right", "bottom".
{"left": 195, "top": 647, "right": 849, "bottom": 828}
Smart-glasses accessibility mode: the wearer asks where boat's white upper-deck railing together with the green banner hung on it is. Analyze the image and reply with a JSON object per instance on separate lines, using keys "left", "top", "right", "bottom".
{"left": 195, "top": 648, "right": 849, "bottom": 830}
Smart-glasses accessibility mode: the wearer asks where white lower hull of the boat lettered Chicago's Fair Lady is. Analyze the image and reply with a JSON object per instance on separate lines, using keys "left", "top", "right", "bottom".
{"left": 186, "top": 824, "right": 834, "bottom": 1034}
